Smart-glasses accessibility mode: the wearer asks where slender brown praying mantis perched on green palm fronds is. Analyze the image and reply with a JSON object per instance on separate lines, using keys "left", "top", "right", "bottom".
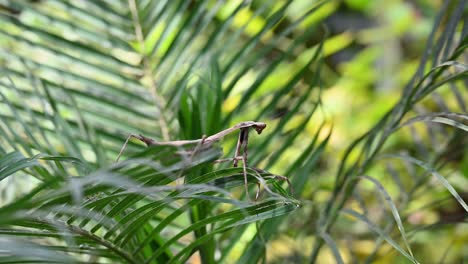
{"left": 116, "top": 121, "right": 292, "bottom": 200}
